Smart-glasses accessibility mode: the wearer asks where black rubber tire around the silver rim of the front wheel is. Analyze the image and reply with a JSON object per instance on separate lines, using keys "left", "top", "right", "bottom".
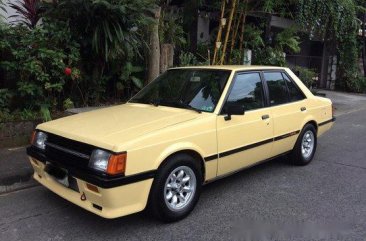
{"left": 149, "top": 153, "right": 203, "bottom": 222}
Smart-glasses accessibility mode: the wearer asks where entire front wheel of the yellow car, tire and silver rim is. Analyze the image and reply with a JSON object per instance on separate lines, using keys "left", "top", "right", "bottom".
{"left": 149, "top": 154, "right": 202, "bottom": 222}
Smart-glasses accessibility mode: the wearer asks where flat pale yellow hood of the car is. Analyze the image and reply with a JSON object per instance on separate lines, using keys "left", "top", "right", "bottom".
{"left": 37, "top": 103, "right": 200, "bottom": 150}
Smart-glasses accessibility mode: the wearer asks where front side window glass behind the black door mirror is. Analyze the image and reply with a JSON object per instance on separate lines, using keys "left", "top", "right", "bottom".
{"left": 225, "top": 73, "right": 264, "bottom": 111}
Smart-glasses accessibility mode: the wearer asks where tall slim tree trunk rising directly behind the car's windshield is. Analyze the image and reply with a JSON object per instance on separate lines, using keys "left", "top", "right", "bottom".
{"left": 147, "top": 7, "right": 161, "bottom": 83}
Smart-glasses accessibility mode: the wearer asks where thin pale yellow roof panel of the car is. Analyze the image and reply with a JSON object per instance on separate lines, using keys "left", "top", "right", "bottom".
{"left": 171, "top": 65, "right": 286, "bottom": 71}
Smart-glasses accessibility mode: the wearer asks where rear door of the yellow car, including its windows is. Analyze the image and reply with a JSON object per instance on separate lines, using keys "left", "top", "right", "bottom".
{"left": 263, "top": 71, "right": 306, "bottom": 156}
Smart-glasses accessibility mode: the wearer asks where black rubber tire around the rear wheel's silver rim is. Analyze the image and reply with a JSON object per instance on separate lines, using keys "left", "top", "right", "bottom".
{"left": 290, "top": 124, "right": 317, "bottom": 166}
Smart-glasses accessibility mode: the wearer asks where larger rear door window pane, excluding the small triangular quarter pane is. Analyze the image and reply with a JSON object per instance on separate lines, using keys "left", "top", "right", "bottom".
{"left": 263, "top": 72, "right": 289, "bottom": 106}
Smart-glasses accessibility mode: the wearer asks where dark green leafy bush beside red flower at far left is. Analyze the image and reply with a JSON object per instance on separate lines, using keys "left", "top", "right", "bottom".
{"left": 0, "top": 19, "right": 79, "bottom": 113}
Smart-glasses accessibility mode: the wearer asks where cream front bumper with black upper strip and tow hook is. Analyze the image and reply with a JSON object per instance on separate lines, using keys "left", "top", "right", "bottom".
{"left": 27, "top": 147, "right": 153, "bottom": 218}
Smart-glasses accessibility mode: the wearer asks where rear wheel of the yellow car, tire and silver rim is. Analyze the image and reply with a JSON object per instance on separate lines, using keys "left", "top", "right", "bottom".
{"left": 291, "top": 124, "right": 317, "bottom": 166}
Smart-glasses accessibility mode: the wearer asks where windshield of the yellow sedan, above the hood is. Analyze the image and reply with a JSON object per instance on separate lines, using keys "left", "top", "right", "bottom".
{"left": 130, "top": 69, "right": 230, "bottom": 112}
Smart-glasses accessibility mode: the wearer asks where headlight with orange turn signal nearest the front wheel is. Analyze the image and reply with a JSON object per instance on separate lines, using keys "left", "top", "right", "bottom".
{"left": 89, "top": 149, "right": 127, "bottom": 175}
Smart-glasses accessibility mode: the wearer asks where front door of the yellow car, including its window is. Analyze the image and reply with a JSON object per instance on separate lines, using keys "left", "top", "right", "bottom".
{"left": 217, "top": 72, "right": 273, "bottom": 176}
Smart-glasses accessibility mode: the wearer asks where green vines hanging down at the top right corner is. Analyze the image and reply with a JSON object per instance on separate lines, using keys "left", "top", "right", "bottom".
{"left": 297, "top": 0, "right": 359, "bottom": 90}
